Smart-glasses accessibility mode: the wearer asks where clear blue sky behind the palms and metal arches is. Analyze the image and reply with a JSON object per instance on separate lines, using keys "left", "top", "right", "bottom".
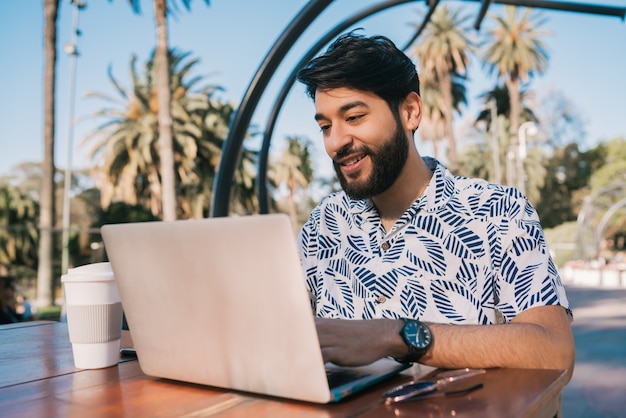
{"left": 0, "top": 0, "right": 626, "bottom": 179}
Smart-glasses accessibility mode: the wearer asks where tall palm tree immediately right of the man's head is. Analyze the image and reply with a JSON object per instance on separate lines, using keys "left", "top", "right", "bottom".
{"left": 414, "top": 5, "right": 473, "bottom": 171}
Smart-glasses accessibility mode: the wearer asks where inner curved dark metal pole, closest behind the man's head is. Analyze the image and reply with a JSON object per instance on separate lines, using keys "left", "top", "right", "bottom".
{"left": 257, "top": 0, "right": 416, "bottom": 213}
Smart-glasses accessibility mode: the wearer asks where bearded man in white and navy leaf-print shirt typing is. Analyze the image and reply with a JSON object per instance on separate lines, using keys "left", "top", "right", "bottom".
{"left": 298, "top": 33, "right": 574, "bottom": 375}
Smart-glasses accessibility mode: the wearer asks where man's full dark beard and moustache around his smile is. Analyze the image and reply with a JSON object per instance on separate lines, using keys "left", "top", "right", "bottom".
{"left": 333, "top": 123, "right": 409, "bottom": 200}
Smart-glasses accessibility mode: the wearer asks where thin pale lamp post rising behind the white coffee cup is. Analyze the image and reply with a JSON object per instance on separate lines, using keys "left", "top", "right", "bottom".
{"left": 61, "top": 0, "right": 85, "bottom": 274}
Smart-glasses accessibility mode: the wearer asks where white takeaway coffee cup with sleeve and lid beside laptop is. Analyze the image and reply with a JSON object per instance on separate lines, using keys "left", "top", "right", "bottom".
{"left": 61, "top": 263, "right": 122, "bottom": 369}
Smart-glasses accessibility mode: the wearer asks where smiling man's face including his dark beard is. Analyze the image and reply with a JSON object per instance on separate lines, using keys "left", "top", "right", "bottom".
{"left": 315, "top": 88, "right": 409, "bottom": 199}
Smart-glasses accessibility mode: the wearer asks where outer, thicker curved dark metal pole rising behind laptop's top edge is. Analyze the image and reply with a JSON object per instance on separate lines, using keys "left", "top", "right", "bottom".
{"left": 210, "top": 0, "right": 333, "bottom": 217}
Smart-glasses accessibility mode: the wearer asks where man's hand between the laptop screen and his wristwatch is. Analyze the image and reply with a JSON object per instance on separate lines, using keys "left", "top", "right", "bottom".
{"left": 315, "top": 318, "right": 407, "bottom": 366}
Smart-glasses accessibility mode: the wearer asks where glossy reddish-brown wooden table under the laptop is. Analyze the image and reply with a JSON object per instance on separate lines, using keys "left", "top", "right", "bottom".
{"left": 0, "top": 322, "right": 566, "bottom": 418}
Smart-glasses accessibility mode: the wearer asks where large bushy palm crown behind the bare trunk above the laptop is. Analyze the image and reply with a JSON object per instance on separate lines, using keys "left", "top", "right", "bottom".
{"left": 83, "top": 51, "right": 233, "bottom": 218}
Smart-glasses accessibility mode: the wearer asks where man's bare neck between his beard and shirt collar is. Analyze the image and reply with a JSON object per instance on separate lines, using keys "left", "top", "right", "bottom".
{"left": 372, "top": 148, "right": 433, "bottom": 231}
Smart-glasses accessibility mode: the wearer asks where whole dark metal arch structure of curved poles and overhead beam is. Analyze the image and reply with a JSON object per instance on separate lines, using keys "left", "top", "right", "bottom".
{"left": 210, "top": 0, "right": 626, "bottom": 217}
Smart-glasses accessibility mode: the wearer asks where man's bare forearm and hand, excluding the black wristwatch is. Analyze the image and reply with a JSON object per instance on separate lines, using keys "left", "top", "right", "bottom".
{"left": 315, "top": 306, "right": 575, "bottom": 377}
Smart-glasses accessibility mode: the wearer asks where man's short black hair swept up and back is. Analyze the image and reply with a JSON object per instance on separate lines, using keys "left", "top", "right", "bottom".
{"left": 298, "top": 31, "right": 419, "bottom": 113}
